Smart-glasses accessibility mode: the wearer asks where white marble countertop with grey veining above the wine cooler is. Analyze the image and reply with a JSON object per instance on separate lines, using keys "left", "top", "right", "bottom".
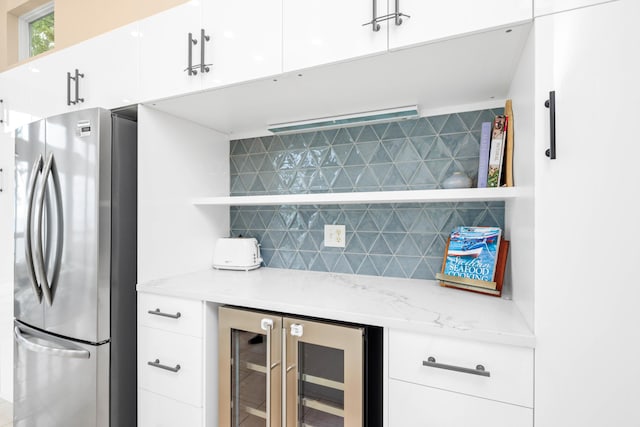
{"left": 137, "top": 268, "right": 535, "bottom": 348}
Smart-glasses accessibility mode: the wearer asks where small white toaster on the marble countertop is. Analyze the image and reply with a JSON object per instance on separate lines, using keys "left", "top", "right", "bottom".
{"left": 213, "top": 237, "right": 262, "bottom": 271}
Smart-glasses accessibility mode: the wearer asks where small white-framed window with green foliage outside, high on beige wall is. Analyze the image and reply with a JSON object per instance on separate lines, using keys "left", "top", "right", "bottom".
{"left": 19, "top": 2, "right": 55, "bottom": 60}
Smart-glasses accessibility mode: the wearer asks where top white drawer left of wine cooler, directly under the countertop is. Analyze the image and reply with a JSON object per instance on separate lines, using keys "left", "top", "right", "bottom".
{"left": 138, "top": 293, "right": 202, "bottom": 337}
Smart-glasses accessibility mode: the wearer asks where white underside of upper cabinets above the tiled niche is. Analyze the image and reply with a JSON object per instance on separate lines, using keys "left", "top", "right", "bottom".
{"left": 147, "top": 25, "right": 531, "bottom": 139}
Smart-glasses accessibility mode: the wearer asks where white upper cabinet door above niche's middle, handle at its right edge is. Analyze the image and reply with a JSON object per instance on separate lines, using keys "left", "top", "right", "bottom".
{"left": 282, "top": 0, "right": 388, "bottom": 72}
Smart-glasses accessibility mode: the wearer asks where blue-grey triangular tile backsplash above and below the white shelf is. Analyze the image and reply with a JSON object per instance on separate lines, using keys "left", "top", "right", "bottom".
{"left": 230, "top": 109, "right": 504, "bottom": 279}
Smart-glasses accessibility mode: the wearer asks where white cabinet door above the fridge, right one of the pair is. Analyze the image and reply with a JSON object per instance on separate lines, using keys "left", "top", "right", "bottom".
{"left": 72, "top": 23, "right": 139, "bottom": 109}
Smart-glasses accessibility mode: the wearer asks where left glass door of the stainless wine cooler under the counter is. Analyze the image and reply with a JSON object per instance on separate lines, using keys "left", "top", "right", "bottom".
{"left": 219, "top": 308, "right": 282, "bottom": 427}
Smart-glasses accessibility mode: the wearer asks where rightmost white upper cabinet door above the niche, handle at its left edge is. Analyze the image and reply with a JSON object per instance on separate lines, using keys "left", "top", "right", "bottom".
{"left": 389, "top": 0, "right": 532, "bottom": 50}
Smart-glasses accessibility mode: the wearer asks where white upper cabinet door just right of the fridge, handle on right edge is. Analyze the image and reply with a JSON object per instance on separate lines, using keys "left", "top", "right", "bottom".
{"left": 139, "top": 0, "right": 202, "bottom": 101}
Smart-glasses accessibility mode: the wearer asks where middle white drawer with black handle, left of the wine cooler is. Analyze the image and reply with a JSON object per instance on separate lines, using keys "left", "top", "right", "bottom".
{"left": 138, "top": 327, "right": 204, "bottom": 406}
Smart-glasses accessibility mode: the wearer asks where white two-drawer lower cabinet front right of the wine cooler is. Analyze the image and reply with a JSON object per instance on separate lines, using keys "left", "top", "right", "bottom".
{"left": 388, "top": 330, "right": 533, "bottom": 427}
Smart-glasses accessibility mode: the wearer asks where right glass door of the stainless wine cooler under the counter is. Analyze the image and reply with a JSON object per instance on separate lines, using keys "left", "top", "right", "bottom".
{"left": 284, "top": 318, "right": 363, "bottom": 427}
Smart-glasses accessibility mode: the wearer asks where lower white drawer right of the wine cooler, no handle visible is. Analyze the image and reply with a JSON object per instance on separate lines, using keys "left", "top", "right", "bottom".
{"left": 389, "top": 380, "right": 533, "bottom": 427}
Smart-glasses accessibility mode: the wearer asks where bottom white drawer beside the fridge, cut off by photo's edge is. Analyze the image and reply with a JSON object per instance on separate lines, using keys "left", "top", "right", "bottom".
{"left": 138, "top": 390, "right": 203, "bottom": 427}
